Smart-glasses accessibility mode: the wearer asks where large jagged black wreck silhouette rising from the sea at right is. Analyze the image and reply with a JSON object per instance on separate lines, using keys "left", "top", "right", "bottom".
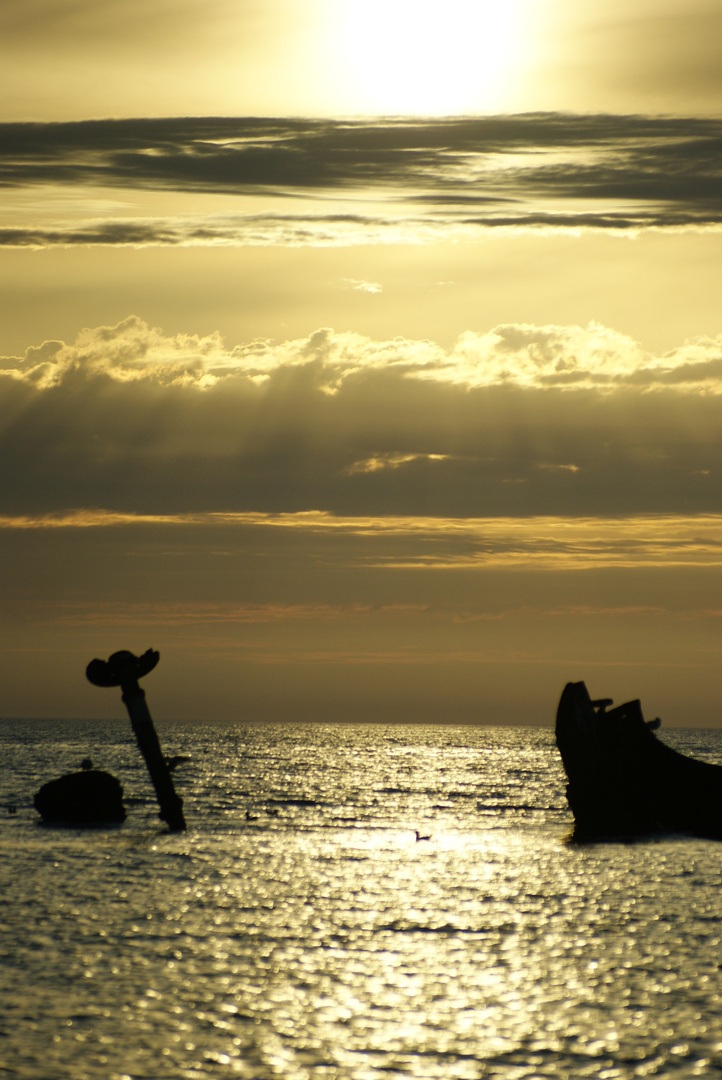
{"left": 556, "top": 683, "right": 722, "bottom": 840}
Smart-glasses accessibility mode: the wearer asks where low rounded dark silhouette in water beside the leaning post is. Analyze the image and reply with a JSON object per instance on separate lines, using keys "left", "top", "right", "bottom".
{"left": 33, "top": 768, "right": 125, "bottom": 825}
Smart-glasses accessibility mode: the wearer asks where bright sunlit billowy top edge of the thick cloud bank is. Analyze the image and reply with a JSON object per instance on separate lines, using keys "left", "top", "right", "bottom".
{"left": 5, "top": 315, "right": 722, "bottom": 395}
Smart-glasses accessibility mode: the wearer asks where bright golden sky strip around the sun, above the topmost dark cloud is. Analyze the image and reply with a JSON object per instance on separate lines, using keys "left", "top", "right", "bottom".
{"left": 0, "top": 0, "right": 722, "bottom": 120}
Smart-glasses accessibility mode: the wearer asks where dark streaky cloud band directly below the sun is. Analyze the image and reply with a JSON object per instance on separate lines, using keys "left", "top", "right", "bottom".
{"left": 0, "top": 113, "right": 722, "bottom": 246}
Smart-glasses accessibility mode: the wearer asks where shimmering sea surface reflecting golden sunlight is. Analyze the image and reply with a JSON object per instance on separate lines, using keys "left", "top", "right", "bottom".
{"left": 0, "top": 720, "right": 722, "bottom": 1080}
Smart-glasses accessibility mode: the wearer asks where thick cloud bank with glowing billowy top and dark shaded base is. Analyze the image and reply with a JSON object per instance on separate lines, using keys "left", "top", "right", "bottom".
{"left": 0, "top": 316, "right": 722, "bottom": 517}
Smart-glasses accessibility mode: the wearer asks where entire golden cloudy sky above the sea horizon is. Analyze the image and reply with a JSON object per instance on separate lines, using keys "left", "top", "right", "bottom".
{"left": 0, "top": 0, "right": 722, "bottom": 727}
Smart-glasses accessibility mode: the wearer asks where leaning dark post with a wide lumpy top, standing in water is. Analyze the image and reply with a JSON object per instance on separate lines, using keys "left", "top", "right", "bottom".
{"left": 85, "top": 649, "right": 186, "bottom": 833}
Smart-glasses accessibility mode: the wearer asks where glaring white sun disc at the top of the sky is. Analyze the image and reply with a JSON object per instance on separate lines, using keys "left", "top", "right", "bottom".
{"left": 342, "top": 0, "right": 521, "bottom": 116}
